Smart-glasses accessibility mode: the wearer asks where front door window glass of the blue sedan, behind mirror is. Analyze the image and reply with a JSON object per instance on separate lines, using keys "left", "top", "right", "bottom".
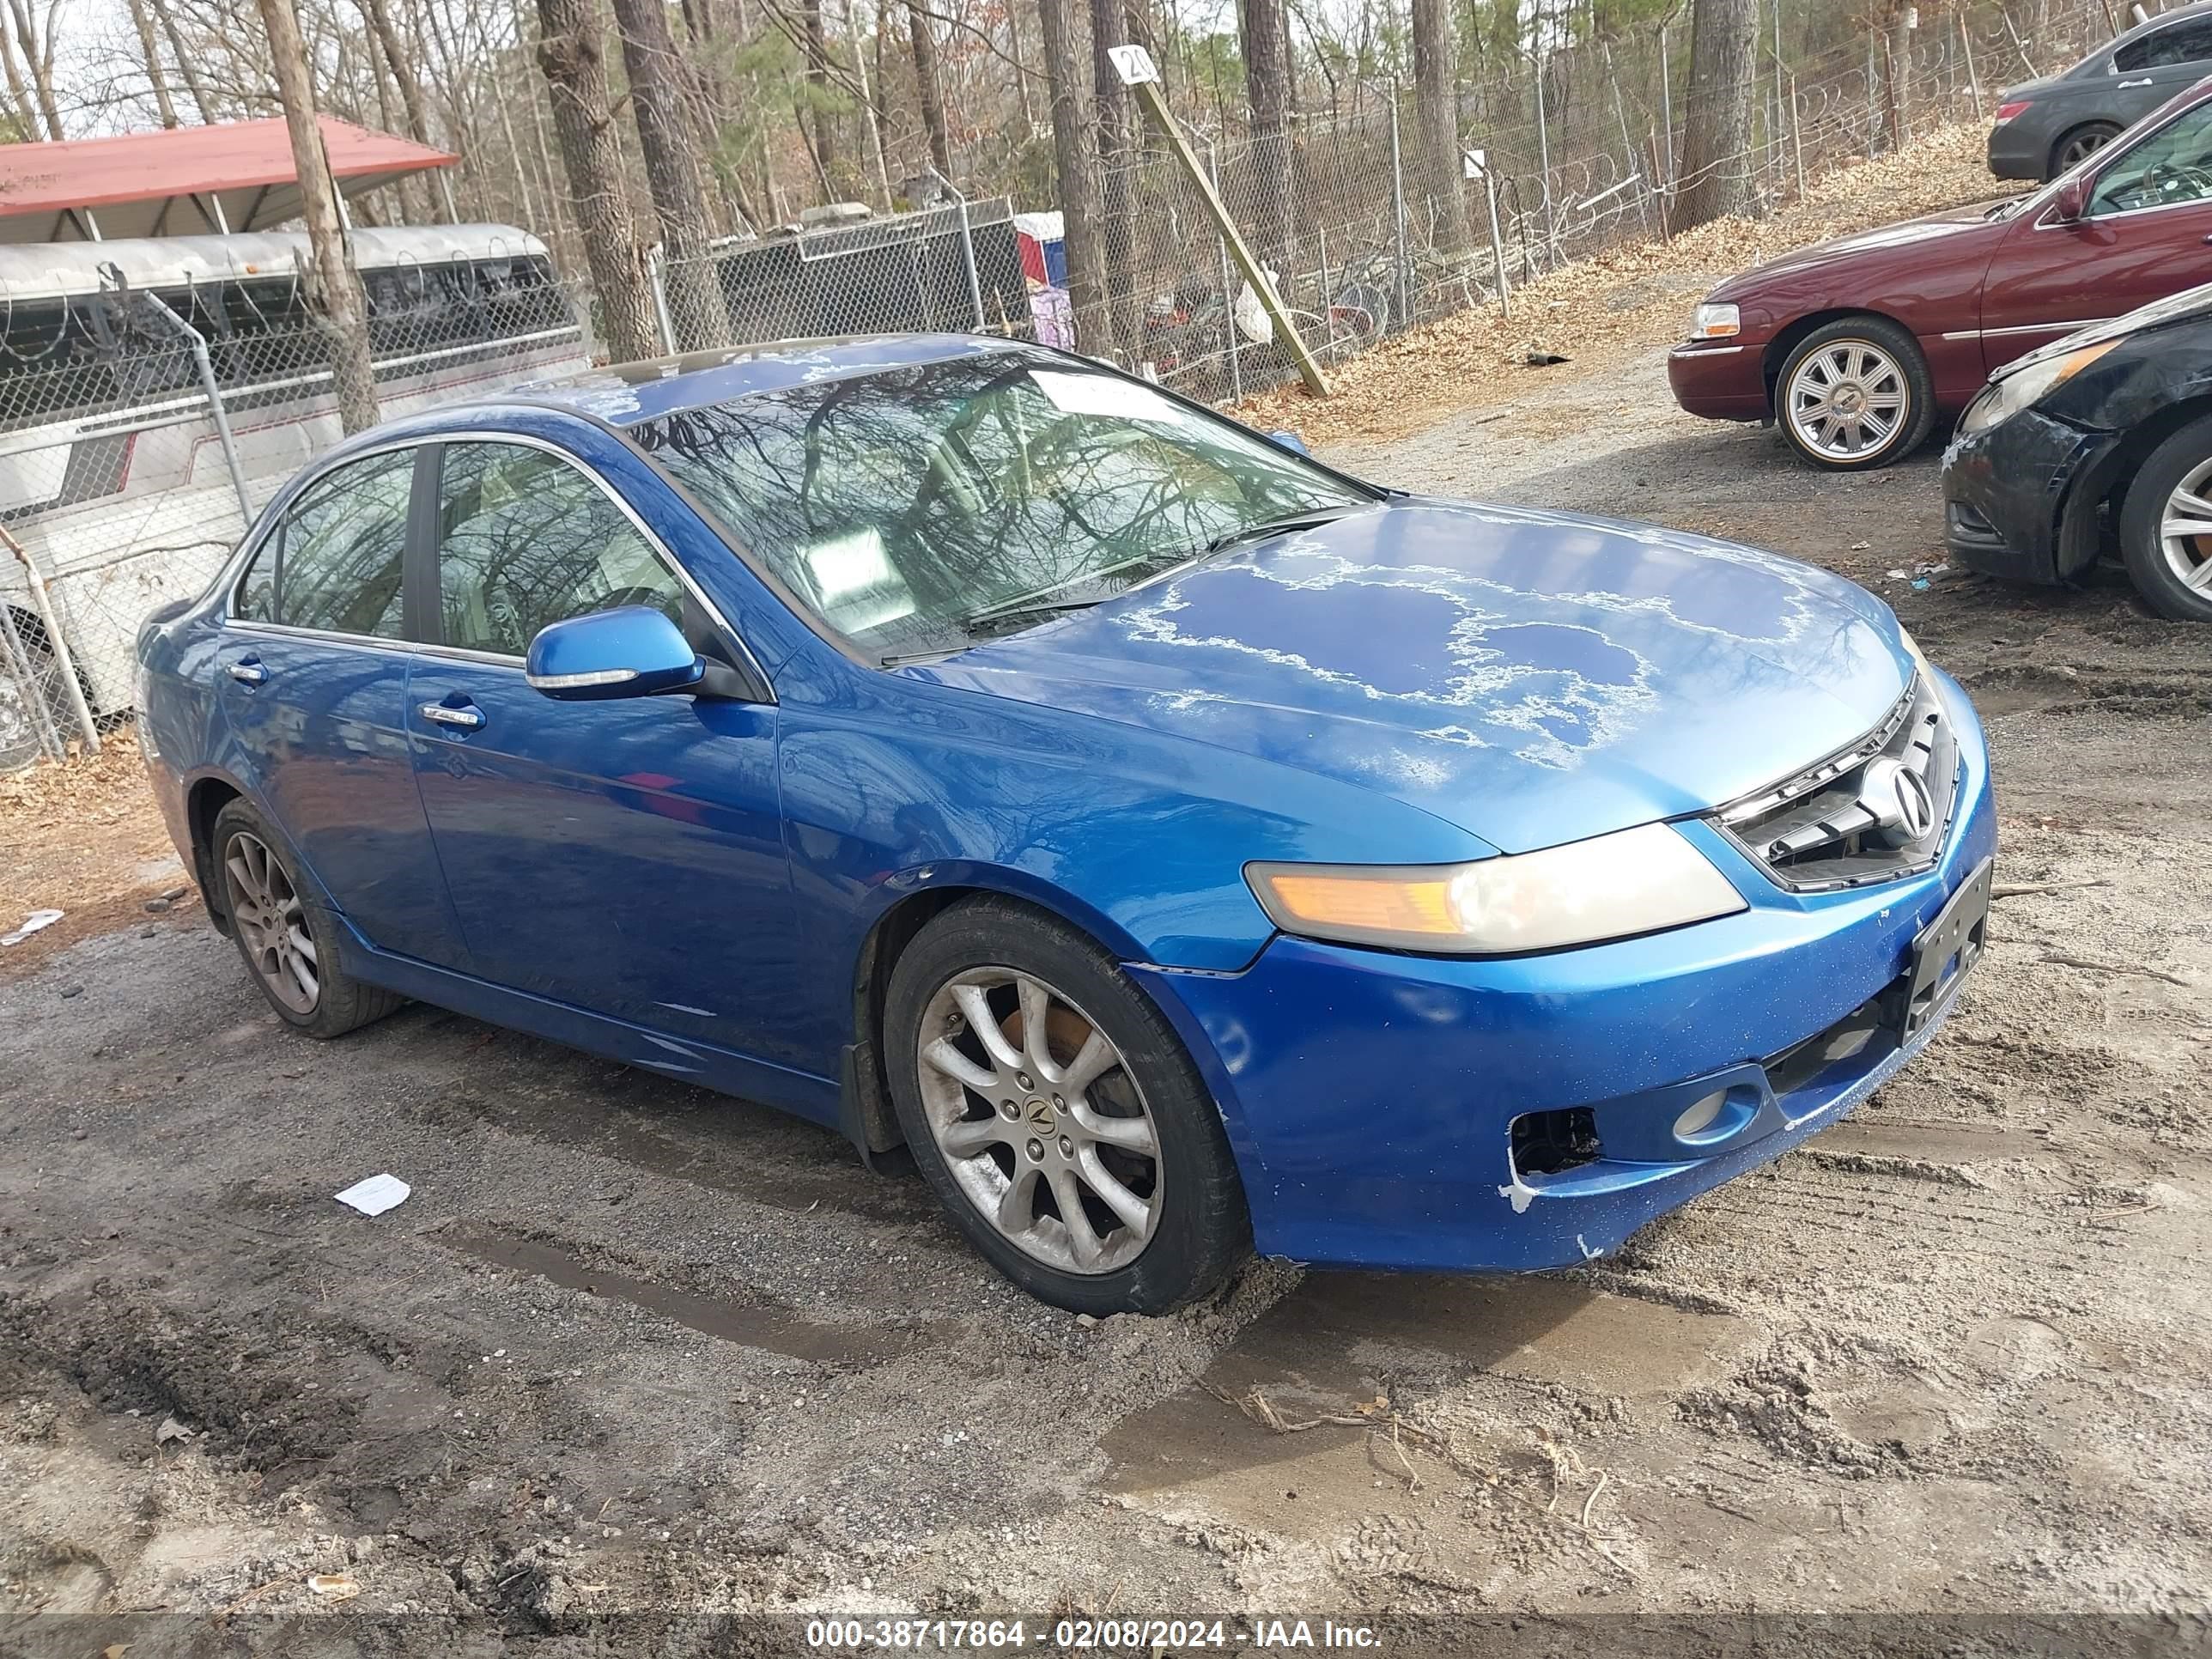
{"left": 438, "top": 442, "right": 684, "bottom": 657}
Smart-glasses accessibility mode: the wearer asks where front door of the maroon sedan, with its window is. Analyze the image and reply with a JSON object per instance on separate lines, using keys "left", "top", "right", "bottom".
{"left": 1982, "top": 100, "right": 2212, "bottom": 369}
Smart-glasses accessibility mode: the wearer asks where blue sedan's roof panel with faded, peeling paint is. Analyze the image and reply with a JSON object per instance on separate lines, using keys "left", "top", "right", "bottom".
{"left": 508, "top": 334, "right": 1064, "bottom": 427}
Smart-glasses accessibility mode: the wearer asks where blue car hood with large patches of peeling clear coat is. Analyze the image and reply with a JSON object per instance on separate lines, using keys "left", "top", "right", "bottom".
{"left": 907, "top": 500, "right": 1911, "bottom": 852}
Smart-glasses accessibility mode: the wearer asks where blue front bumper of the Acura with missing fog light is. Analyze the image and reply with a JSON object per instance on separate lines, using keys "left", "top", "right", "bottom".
{"left": 1133, "top": 684, "right": 1997, "bottom": 1270}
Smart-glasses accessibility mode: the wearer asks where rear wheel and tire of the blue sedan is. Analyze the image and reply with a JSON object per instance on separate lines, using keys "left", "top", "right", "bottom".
{"left": 215, "top": 801, "right": 404, "bottom": 1037}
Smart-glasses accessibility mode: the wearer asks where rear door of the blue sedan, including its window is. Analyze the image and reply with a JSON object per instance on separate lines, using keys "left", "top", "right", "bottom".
{"left": 215, "top": 447, "right": 460, "bottom": 963}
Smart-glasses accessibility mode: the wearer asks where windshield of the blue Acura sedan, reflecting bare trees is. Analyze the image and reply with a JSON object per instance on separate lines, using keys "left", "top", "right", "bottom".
{"left": 629, "top": 352, "right": 1378, "bottom": 657}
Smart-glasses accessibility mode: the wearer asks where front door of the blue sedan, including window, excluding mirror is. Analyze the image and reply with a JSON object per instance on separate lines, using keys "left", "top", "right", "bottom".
{"left": 407, "top": 438, "right": 801, "bottom": 1064}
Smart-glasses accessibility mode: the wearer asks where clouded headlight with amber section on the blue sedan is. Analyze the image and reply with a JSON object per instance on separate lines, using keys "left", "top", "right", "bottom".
{"left": 1245, "top": 823, "right": 1745, "bottom": 956}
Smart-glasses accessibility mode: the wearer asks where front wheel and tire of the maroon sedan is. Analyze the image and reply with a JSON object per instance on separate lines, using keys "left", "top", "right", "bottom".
{"left": 1774, "top": 316, "right": 1936, "bottom": 473}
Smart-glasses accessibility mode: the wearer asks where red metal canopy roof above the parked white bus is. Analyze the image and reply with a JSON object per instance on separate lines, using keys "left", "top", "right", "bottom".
{"left": 0, "top": 115, "right": 460, "bottom": 243}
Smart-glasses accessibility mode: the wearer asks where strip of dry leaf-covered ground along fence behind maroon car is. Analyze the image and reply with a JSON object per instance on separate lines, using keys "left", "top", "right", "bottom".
{"left": 1232, "top": 124, "right": 2006, "bottom": 445}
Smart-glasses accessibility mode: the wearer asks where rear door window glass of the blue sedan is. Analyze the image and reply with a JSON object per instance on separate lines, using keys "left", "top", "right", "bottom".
{"left": 237, "top": 449, "right": 414, "bottom": 639}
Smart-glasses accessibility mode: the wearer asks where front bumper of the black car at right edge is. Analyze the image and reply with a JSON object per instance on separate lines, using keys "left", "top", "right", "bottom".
{"left": 1942, "top": 407, "right": 2119, "bottom": 581}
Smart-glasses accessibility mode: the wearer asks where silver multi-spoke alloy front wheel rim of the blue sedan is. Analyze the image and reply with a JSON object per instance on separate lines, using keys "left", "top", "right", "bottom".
{"left": 915, "top": 967, "right": 1164, "bottom": 1274}
